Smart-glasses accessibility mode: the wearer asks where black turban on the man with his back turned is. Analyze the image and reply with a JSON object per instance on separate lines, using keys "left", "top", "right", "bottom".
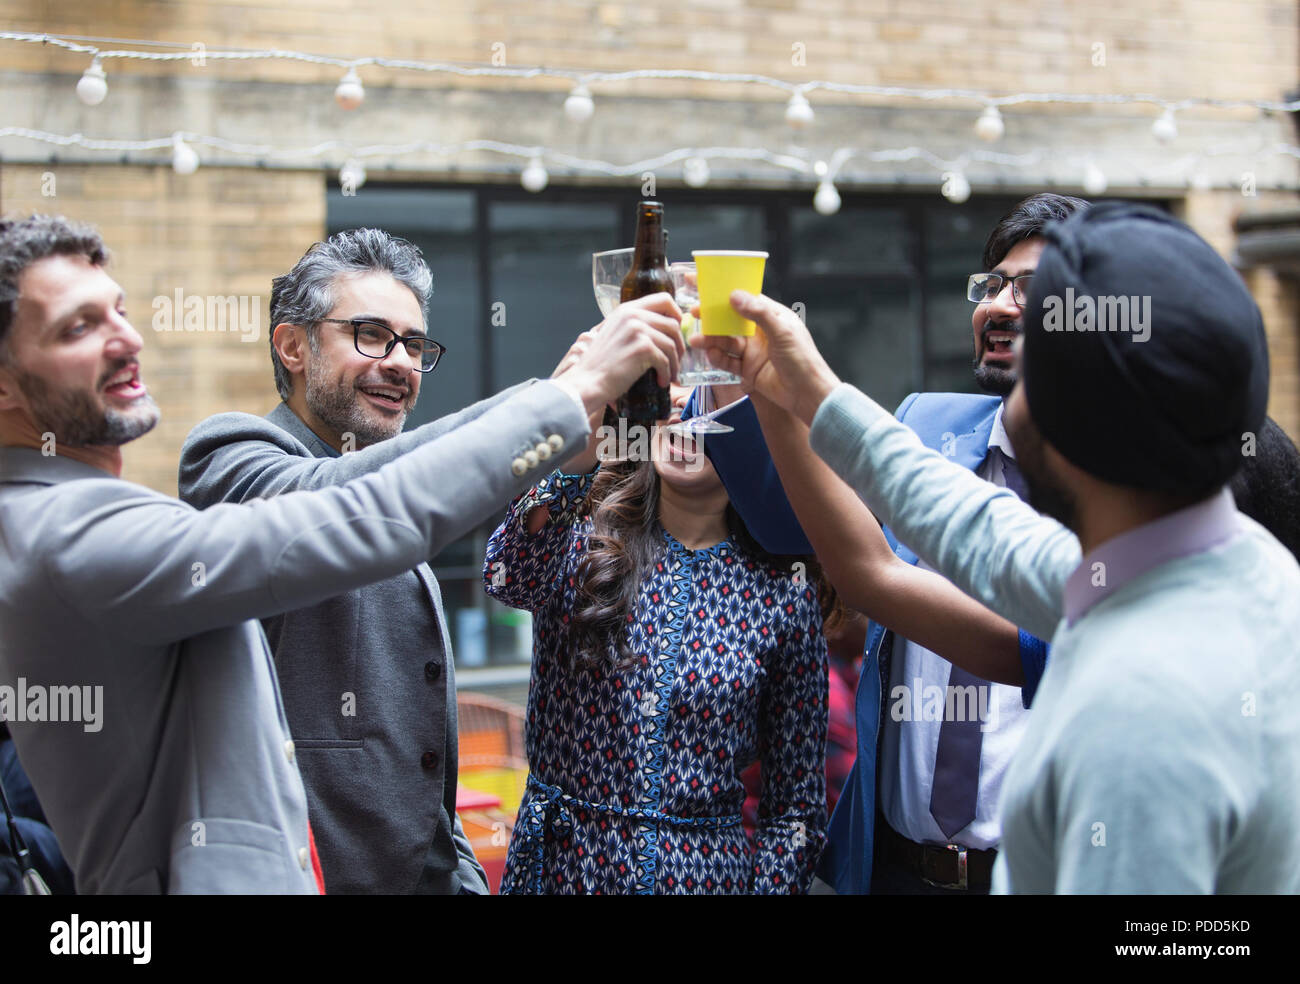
{"left": 1022, "top": 201, "right": 1269, "bottom": 495}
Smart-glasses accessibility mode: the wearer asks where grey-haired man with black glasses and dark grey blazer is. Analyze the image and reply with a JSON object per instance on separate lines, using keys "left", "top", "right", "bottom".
{"left": 181, "top": 229, "right": 655, "bottom": 894}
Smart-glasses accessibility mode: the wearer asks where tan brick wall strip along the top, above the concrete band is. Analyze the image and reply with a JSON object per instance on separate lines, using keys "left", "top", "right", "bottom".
{"left": 0, "top": 0, "right": 1297, "bottom": 103}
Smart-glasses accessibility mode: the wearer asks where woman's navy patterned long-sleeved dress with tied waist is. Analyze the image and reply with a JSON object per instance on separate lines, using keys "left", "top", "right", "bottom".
{"left": 484, "top": 472, "right": 827, "bottom": 894}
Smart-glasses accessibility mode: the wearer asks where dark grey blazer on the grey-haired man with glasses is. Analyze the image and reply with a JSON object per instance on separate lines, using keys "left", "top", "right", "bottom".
{"left": 179, "top": 383, "right": 529, "bottom": 894}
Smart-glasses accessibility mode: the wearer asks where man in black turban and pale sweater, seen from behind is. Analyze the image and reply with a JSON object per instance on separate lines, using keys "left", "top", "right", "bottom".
{"left": 706, "top": 203, "right": 1300, "bottom": 893}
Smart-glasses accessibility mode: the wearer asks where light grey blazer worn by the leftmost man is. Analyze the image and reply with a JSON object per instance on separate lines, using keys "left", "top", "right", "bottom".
{"left": 0, "top": 382, "right": 588, "bottom": 893}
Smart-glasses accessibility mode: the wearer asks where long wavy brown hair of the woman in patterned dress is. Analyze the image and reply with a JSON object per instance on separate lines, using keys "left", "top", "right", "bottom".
{"left": 564, "top": 452, "right": 844, "bottom": 669}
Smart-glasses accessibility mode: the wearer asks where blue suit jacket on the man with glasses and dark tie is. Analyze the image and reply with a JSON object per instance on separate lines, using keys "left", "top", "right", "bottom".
{"left": 705, "top": 393, "right": 1001, "bottom": 894}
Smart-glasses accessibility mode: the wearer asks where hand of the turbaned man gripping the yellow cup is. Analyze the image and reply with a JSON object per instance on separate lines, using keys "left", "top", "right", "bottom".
{"left": 690, "top": 290, "right": 840, "bottom": 424}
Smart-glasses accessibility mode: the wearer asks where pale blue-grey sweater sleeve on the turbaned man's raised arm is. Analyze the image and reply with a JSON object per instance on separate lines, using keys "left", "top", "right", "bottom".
{"left": 810, "top": 383, "right": 1080, "bottom": 640}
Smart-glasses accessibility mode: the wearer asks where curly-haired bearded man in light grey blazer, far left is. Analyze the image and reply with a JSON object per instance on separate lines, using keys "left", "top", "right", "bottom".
{"left": 0, "top": 216, "right": 681, "bottom": 894}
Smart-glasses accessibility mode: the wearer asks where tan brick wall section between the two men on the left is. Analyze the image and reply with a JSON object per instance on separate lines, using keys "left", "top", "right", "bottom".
{"left": 0, "top": 164, "right": 325, "bottom": 495}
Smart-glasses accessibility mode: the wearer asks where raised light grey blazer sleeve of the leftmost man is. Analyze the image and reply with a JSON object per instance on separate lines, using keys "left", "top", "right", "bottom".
{"left": 42, "top": 382, "right": 588, "bottom": 645}
